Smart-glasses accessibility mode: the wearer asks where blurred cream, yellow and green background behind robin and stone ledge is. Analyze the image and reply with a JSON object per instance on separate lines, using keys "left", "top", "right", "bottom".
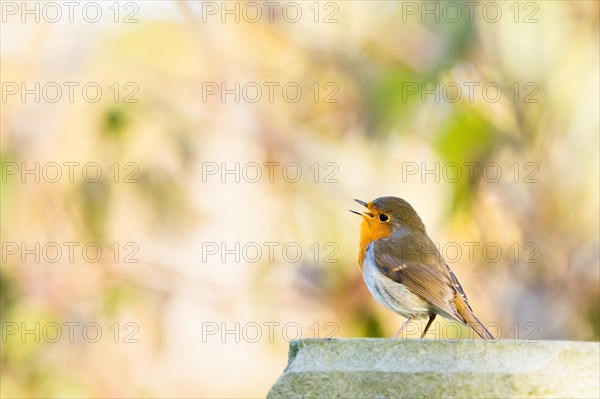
{"left": 0, "top": 1, "right": 600, "bottom": 398}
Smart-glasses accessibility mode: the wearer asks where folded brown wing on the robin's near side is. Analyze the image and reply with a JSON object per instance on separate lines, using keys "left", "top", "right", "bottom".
{"left": 374, "top": 248, "right": 465, "bottom": 323}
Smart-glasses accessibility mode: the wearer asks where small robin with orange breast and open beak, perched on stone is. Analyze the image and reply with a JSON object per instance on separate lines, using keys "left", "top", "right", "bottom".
{"left": 350, "top": 197, "right": 494, "bottom": 339}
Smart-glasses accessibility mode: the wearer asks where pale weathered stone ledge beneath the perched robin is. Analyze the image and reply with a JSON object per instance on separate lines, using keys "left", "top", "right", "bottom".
{"left": 267, "top": 338, "right": 600, "bottom": 399}
